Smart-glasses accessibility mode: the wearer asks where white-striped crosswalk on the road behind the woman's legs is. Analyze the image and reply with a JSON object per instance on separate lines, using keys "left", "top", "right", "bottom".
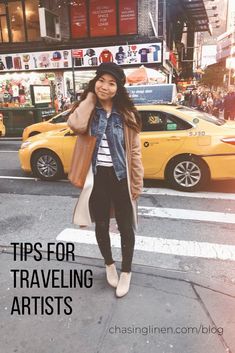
{"left": 57, "top": 188, "right": 235, "bottom": 263}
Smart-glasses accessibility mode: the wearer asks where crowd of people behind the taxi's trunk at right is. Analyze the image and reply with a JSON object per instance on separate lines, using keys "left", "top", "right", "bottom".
{"left": 176, "top": 87, "right": 235, "bottom": 120}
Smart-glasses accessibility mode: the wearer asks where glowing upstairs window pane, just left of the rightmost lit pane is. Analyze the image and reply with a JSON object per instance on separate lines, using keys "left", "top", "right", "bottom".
{"left": 8, "top": 1, "right": 25, "bottom": 43}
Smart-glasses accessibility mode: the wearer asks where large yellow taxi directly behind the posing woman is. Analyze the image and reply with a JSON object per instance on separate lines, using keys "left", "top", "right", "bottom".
{"left": 19, "top": 104, "right": 235, "bottom": 191}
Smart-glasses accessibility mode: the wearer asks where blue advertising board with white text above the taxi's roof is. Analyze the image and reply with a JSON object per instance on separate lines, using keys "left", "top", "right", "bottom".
{"left": 126, "top": 84, "right": 177, "bottom": 104}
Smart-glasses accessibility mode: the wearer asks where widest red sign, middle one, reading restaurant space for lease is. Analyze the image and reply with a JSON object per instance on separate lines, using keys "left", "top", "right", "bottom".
{"left": 90, "top": 0, "right": 117, "bottom": 37}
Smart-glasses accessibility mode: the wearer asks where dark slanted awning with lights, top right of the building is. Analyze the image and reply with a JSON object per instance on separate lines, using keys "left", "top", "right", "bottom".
{"left": 182, "top": 0, "right": 211, "bottom": 33}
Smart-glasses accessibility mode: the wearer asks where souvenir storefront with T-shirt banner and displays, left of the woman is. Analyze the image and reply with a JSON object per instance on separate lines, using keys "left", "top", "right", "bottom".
{"left": 0, "top": 50, "right": 72, "bottom": 107}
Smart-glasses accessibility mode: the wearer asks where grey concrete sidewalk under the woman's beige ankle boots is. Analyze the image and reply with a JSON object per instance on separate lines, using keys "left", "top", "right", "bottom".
{"left": 0, "top": 245, "right": 235, "bottom": 353}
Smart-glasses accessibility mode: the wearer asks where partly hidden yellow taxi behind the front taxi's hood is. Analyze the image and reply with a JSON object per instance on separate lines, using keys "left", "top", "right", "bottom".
{"left": 22, "top": 109, "right": 70, "bottom": 141}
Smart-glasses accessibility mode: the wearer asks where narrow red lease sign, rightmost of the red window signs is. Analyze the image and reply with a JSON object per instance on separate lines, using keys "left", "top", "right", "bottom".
{"left": 119, "top": 0, "right": 138, "bottom": 34}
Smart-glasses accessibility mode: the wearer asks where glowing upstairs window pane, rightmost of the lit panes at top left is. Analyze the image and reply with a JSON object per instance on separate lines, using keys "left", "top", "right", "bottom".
{"left": 25, "top": 0, "right": 41, "bottom": 41}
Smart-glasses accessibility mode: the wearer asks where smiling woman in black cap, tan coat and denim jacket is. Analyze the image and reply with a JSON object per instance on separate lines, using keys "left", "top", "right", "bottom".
{"left": 68, "top": 63, "right": 143, "bottom": 297}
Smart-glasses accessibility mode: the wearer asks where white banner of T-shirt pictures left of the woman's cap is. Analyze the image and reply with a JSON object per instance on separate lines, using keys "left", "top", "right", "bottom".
{"left": 0, "top": 50, "right": 72, "bottom": 72}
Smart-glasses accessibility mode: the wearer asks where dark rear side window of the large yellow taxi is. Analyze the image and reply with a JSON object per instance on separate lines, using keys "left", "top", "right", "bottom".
{"left": 140, "top": 111, "right": 192, "bottom": 131}
